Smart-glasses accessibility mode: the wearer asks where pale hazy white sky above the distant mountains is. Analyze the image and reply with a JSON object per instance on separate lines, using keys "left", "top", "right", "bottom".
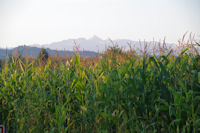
{"left": 0, "top": 0, "right": 200, "bottom": 47}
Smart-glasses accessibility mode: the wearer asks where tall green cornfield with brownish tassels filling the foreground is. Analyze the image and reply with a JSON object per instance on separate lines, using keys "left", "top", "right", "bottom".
{"left": 0, "top": 40, "right": 200, "bottom": 133}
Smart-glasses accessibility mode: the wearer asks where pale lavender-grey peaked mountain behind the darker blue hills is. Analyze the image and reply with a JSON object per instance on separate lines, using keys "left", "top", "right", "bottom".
{"left": 32, "top": 36, "right": 174, "bottom": 52}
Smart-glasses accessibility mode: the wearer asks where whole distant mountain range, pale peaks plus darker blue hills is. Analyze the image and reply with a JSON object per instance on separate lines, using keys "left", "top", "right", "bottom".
{"left": 0, "top": 36, "right": 175, "bottom": 58}
